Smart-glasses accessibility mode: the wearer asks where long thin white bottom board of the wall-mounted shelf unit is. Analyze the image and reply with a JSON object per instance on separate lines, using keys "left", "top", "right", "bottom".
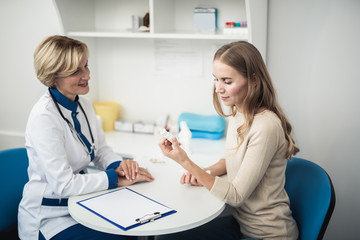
{"left": 67, "top": 29, "right": 248, "bottom": 40}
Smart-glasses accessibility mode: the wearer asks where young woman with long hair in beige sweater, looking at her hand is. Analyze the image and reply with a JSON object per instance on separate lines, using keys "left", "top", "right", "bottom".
{"left": 157, "top": 41, "right": 299, "bottom": 240}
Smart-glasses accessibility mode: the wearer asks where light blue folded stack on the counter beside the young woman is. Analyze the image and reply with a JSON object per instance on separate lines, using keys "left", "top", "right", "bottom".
{"left": 178, "top": 112, "right": 225, "bottom": 140}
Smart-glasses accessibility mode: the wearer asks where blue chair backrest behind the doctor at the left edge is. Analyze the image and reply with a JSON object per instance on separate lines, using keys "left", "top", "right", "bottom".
{"left": 0, "top": 148, "right": 29, "bottom": 231}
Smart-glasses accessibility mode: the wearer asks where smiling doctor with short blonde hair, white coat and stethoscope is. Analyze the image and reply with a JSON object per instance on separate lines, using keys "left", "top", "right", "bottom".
{"left": 18, "top": 36, "right": 153, "bottom": 240}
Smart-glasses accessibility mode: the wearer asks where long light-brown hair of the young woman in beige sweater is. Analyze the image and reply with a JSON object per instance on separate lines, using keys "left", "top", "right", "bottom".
{"left": 213, "top": 41, "right": 299, "bottom": 158}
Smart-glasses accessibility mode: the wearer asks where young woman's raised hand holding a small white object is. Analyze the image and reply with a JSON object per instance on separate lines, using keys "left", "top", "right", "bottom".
{"left": 159, "top": 137, "right": 190, "bottom": 165}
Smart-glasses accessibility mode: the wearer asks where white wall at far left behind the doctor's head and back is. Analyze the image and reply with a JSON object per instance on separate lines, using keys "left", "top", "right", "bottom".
{"left": 0, "top": 0, "right": 61, "bottom": 149}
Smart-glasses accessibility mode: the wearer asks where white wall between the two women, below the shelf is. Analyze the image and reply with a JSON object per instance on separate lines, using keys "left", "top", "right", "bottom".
{"left": 94, "top": 39, "right": 224, "bottom": 121}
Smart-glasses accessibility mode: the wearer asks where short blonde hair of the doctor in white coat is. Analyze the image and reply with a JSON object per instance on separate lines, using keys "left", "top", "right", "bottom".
{"left": 34, "top": 35, "right": 89, "bottom": 87}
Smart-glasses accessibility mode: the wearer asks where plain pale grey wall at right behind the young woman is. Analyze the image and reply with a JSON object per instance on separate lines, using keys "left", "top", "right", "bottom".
{"left": 267, "top": 0, "right": 360, "bottom": 239}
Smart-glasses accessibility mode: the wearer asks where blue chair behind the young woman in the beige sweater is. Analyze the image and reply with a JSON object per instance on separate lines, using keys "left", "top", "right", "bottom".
{"left": 285, "top": 158, "right": 335, "bottom": 240}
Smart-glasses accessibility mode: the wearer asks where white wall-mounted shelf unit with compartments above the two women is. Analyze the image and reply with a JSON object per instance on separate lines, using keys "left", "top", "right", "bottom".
{"left": 53, "top": 0, "right": 268, "bottom": 57}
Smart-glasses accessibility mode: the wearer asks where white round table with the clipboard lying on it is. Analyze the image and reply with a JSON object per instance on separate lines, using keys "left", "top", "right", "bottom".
{"left": 68, "top": 155, "right": 225, "bottom": 236}
